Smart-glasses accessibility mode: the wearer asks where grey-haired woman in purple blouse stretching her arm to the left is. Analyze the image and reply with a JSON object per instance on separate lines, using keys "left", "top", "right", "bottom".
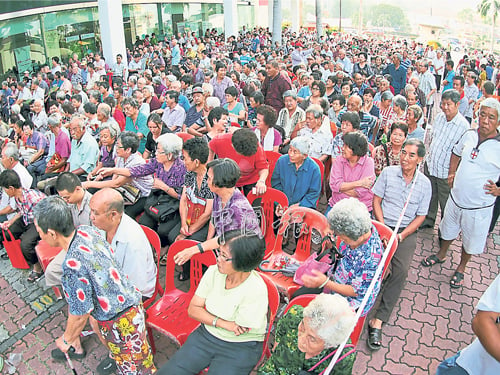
{"left": 99, "top": 134, "right": 186, "bottom": 219}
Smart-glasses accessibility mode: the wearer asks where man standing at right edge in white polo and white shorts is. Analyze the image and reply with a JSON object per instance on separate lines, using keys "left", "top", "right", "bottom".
{"left": 422, "top": 98, "right": 500, "bottom": 288}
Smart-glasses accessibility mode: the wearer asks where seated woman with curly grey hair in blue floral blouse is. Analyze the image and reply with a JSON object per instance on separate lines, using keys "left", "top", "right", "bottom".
{"left": 294, "top": 198, "right": 384, "bottom": 316}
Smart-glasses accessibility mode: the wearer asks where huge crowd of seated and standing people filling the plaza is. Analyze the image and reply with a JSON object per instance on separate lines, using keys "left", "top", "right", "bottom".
{"left": 0, "top": 28, "right": 500, "bottom": 374}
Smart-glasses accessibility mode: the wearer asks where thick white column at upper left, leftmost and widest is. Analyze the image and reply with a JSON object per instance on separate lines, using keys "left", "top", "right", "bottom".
{"left": 97, "top": 0, "right": 127, "bottom": 66}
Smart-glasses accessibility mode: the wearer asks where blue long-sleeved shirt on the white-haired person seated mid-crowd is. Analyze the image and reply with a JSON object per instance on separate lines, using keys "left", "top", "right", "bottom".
{"left": 271, "top": 155, "right": 321, "bottom": 208}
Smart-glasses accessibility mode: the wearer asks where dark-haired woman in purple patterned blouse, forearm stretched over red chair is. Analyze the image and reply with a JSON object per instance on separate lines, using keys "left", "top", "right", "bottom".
{"left": 174, "top": 158, "right": 261, "bottom": 274}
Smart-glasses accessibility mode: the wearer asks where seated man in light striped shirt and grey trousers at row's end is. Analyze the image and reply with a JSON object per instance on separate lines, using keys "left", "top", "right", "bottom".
{"left": 367, "top": 139, "right": 431, "bottom": 350}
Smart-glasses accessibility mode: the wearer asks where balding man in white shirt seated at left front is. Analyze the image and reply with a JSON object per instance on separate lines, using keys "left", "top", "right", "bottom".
{"left": 90, "top": 188, "right": 157, "bottom": 299}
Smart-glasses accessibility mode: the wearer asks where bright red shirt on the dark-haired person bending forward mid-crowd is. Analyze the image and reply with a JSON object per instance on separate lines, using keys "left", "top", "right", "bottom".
{"left": 208, "top": 133, "right": 269, "bottom": 187}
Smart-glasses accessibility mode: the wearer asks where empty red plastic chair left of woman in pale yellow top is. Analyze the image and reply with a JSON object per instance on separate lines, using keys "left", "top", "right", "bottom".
{"left": 146, "top": 240, "right": 216, "bottom": 353}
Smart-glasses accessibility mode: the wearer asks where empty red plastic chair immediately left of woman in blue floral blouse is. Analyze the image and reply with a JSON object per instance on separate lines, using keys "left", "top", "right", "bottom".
{"left": 263, "top": 207, "right": 329, "bottom": 299}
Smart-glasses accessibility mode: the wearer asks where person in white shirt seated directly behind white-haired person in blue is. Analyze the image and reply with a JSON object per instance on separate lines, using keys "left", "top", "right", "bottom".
{"left": 295, "top": 105, "right": 333, "bottom": 163}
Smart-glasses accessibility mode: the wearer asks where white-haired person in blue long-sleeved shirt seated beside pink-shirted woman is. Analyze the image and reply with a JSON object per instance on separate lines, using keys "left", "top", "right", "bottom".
{"left": 271, "top": 137, "right": 321, "bottom": 209}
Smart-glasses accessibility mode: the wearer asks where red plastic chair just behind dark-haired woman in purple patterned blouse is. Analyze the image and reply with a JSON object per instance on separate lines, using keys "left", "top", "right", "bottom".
{"left": 247, "top": 188, "right": 288, "bottom": 258}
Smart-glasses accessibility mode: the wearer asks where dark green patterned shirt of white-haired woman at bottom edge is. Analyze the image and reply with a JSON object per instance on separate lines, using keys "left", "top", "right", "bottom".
{"left": 257, "top": 305, "right": 356, "bottom": 375}
